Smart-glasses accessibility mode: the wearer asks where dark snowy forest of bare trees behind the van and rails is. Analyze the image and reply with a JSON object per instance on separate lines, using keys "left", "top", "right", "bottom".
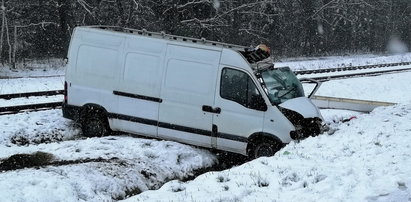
{"left": 0, "top": 0, "right": 411, "bottom": 64}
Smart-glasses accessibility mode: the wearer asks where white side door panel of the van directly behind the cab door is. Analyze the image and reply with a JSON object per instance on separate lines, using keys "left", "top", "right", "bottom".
{"left": 158, "top": 45, "right": 221, "bottom": 147}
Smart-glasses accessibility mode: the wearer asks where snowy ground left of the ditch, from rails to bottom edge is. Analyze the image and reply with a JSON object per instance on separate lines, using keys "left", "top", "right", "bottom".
{"left": 0, "top": 110, "right": 217, "bottom": 201}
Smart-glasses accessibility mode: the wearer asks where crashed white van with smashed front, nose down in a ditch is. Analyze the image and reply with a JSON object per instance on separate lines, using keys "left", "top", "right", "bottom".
{"left": 63, "top": 26, "right": 322, "bottom": 158}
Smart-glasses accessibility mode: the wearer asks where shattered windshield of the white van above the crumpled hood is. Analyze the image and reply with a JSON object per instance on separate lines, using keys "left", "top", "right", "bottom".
{"left": 259, "top": 67, "right": 304, "bottom": 105}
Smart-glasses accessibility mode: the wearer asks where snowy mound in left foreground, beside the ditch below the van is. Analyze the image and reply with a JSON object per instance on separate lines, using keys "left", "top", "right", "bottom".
{"left": 0, "top": 133, "right": 215, "bottom": 201}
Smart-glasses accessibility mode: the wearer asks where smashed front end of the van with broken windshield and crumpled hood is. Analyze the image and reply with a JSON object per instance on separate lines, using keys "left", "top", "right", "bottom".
{"left": 255, "top": 64, "right": 323, "bottom": 140}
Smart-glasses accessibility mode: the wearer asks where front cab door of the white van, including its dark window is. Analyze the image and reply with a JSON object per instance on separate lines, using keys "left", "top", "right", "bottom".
{"left": 213, "top": 67, "right": 267, "bottom": 154}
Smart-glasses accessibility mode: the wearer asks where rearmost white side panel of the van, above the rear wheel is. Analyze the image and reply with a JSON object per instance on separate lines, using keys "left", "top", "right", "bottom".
{"left": 66, "top": 28, "right": 124, "bottom": 126}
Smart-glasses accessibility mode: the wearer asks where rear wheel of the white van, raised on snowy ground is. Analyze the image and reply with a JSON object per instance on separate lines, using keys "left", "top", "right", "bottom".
{"left": 81, "top": 109, "right": 110, "bottom": 137}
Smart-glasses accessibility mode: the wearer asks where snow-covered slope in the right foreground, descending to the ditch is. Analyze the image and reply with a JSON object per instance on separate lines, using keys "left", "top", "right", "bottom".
{"left": 128, "top": 103, "right": 411, "bottom": 201}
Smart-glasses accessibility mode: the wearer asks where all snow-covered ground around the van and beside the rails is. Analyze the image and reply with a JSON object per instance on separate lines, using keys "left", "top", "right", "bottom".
{"left": 0, "top": 54, "right": 411, "bottom": 201}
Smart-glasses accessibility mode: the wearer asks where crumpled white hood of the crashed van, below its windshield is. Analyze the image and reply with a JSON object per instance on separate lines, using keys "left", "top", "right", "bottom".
{"left": 279, "top": 97, "right": 324, "bottom": 120}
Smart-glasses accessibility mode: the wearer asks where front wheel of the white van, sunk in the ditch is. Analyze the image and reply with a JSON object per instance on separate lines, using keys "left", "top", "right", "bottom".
{"left": 248, "top": 137, "right": 282, "bottom": 159}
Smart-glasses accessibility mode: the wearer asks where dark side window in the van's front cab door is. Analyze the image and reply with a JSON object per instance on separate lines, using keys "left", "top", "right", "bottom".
{"left": 220, "top": 68, "right": 261, "bottom": 109}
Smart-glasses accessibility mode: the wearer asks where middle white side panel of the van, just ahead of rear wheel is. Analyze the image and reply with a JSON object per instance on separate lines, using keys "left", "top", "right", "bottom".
{"left": 111, "top": 36, "right": 167, "bottom": 137}
